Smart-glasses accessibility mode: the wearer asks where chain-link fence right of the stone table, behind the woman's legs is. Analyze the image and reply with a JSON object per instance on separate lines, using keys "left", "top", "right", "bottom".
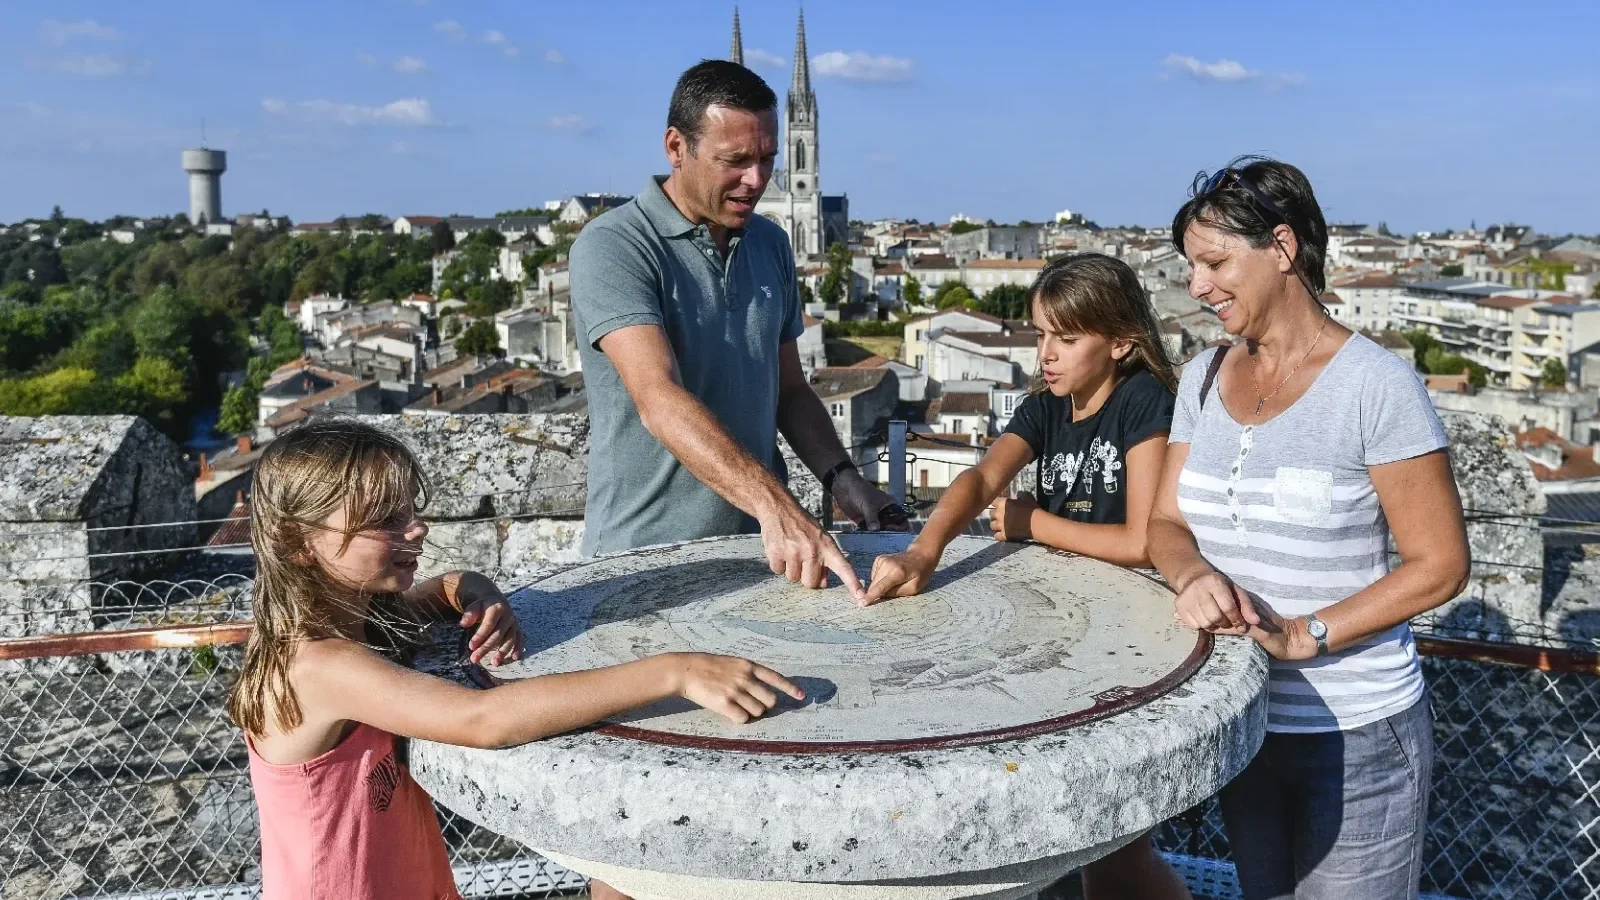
{"left": 1157, "top": 613, "right": 1600, "bottom": 900}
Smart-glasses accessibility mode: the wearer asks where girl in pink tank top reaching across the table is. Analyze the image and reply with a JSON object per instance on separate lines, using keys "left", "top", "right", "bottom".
{"left": 227, "top": 418, "right": 803, "bottom": 900}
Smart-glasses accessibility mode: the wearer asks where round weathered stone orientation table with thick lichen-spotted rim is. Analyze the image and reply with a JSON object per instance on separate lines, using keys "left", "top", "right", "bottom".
{"left": 410, "top": 535, "right": 1267, "bottom": 900}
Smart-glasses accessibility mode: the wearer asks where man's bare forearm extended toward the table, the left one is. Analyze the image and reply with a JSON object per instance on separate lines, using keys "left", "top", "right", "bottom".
{"left": 642, "top": 377, "right": 794, "bottom": 519}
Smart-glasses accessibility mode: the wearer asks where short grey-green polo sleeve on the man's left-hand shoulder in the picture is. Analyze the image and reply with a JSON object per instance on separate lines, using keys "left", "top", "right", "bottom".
{"left": 566, "top": 223, "right": 666, "bottom": 349}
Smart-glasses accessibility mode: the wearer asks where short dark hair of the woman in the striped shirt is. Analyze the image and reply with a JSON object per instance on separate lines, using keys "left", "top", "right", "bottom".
{"left": 1173, "top": 155, "right": 1328, "bottom": 293}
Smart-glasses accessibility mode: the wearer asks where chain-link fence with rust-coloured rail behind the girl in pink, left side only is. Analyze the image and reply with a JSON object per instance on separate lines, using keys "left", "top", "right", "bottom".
{"left": 0, "top": 575, "right": 584, "bottom": 900}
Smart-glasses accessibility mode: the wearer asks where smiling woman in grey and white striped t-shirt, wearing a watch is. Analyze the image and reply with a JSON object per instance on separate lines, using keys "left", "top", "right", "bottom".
{"left": 1149, "top": 159, "right": 1467, "bottom": 900}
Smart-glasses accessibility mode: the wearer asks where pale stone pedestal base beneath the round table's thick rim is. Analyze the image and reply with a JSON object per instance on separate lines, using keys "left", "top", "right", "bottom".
{"left": 556, "top": 836, "right": 1136, "bottom": 900}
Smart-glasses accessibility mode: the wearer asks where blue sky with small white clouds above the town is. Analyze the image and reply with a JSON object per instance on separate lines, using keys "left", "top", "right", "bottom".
{"left": 0, "top": 0, "right": 1600, "bottom": 232}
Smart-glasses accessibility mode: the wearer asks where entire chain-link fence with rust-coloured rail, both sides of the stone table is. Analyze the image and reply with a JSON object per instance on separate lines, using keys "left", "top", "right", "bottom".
{"left": 0, "top": 572, "right": 1600, "bottom": 900}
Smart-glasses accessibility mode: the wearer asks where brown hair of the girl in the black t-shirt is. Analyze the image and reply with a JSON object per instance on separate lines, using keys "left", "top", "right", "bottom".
{"left": 1027, "top": 253, "right": 1178, "bottom": 391}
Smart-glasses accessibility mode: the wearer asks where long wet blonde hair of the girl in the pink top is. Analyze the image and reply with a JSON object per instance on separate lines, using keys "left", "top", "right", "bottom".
{"left": 227, "top": 418, "right": 427, "bottom": 735}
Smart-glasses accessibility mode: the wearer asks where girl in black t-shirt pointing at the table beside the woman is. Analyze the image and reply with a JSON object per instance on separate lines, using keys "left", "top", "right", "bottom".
{"left": 866, "top": 253, "right": 1189, "bottom": 900}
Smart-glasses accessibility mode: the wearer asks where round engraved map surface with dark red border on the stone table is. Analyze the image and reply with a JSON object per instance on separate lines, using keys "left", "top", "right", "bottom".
{"left": 493, "top": 535, "right": 1210, "bottom": 753}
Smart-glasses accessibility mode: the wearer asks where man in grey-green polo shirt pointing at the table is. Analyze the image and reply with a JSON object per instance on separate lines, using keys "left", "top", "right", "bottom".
{"left": 570, "top": 61, "right": 899, "bottom": 599}
